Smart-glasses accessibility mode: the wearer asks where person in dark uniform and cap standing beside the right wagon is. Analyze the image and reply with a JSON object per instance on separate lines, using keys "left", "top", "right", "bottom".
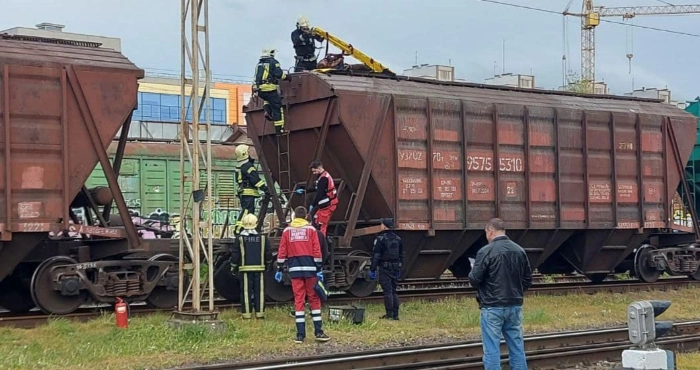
{"left": 370, "top": 218, "right": 404, "bottom": 320}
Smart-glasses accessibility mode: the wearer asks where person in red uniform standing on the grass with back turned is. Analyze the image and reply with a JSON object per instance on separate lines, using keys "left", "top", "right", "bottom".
{"left": 275, "top": 207, "right": 330, "bottom": 343}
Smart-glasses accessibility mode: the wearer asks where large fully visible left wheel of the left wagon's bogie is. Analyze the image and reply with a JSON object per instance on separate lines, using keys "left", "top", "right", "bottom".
{"left": 30, "top": 256, "right": 88, "bottom": 315}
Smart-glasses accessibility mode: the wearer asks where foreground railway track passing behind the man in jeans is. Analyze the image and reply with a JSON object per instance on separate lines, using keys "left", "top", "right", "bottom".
{"left": 181, "top": 321, "right": 700, "bottom": 370}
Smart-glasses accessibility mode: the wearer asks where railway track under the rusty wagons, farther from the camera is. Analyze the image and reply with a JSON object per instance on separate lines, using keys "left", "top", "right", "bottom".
{"left": 0, "top": 277, "right": 700, "bottom": 328}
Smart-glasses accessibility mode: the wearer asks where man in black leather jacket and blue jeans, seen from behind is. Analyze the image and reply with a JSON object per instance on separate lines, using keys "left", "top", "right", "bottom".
{"left": 469, "top": 218, "right": 532, "bottom": 370}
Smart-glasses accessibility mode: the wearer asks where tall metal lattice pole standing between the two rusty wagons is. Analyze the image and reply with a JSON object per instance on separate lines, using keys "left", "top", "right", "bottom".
{"left": 170, "top": 0, "right": 223, "bottom": 329}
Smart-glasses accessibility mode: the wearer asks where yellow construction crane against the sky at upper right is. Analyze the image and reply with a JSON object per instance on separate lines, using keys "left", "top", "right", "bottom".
{"left": 564, "top": 0, "right": 700, "bottom": 93}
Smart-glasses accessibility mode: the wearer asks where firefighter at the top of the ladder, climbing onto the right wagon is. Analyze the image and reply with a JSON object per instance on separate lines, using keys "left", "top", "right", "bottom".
{"left": 253, "top": 49, "right": 290, "bottom": 134}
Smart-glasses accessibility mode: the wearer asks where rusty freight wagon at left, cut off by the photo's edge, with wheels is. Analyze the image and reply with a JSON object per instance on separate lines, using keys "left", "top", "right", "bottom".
{"left": 0, "top": 35, "right": 177, "bottom": 314}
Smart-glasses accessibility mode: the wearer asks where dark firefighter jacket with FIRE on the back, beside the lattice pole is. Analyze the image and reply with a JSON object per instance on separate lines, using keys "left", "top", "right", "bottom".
{"left": 231, "top": 230, "right": 272, "bottom": 272}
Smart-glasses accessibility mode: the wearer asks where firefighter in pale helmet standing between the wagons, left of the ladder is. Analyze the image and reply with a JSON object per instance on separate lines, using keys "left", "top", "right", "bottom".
{"left": 233, "top": 144, "right": 269, "bottom": 235}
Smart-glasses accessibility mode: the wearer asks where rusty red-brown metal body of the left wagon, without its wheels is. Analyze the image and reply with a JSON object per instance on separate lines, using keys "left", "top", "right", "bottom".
{"left": 0, "top": 39, "right": 143, "bottom": 279}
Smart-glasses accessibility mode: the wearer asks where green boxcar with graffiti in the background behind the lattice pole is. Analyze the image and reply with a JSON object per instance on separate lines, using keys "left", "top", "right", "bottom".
{"left": 86, "top": 142, "right": 266, "bottom": 236}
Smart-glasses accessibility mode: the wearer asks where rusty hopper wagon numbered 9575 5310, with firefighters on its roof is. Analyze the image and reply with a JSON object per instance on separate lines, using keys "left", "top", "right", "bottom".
{"left": 245, "top": 72, "right": 698, "bottom": 298}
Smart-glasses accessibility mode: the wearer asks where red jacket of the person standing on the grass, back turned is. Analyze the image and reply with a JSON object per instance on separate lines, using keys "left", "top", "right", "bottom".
{"left": 277, "top": 218, "right": 323, "bottom": 279}
